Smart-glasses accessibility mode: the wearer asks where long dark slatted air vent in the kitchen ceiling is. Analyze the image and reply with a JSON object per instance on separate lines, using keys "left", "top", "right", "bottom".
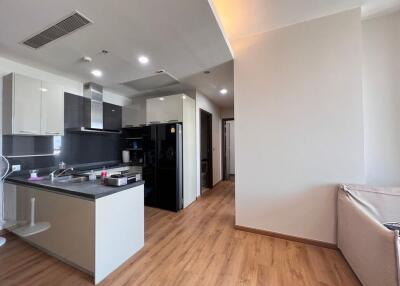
{"left": 22, "top": 11, "right": 93, "bottom": 49}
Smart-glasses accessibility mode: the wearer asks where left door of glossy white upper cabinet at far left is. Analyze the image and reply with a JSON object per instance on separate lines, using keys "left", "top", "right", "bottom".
{"left": 12, "top": 74, "right": 42, "bottom": 135}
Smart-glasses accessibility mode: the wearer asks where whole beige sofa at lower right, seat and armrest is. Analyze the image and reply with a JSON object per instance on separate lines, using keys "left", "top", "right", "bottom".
{"left": 338, "top": 185, "right": 400, "bottom": 286}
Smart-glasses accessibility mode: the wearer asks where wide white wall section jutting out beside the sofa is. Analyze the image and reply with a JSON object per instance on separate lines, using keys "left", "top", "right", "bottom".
{"left": 233, "top": 9, "right": 365, "bottom": 243}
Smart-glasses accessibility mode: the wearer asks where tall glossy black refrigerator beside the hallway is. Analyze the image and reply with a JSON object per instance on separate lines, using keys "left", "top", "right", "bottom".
{"left": 142, "top": 123, "right": 183, "bottom": 211}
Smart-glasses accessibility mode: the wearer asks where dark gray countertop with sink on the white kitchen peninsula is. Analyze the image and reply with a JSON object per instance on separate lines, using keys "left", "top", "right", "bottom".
{"left": 5, "top": 177, "right": 144, "bottom": 200}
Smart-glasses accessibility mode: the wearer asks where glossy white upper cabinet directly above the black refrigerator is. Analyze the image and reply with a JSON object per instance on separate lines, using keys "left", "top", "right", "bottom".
{"left": 146, "top": 94, "right": 184, "bottom": 124}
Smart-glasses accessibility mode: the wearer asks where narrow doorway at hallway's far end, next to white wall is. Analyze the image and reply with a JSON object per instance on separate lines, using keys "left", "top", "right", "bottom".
{"left": 222, "top": 118, "right": 235, "bottom": 181}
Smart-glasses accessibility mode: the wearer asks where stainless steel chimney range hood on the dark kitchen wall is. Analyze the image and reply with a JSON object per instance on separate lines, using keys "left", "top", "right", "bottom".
{"left": 70, "top": 82, "right": 121, "bottom": 133}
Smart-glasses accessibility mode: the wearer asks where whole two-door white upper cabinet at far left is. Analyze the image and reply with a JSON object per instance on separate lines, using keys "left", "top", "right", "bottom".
{"left": 3, "top": 73, "right": 64, "bottom": 135}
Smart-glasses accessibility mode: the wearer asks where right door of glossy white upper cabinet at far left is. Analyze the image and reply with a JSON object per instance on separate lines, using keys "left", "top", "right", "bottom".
{"left": 41, "top": 81, "right": 64, "bottom": 135}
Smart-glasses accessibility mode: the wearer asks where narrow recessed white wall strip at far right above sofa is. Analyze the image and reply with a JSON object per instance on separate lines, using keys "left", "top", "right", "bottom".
{"left": 362, "top": 9, "right": 400, "bottom": 186}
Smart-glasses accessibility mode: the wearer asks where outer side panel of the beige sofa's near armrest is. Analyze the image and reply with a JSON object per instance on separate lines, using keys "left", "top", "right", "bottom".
{"left": 338, "top": 190, "right": 399, "bottom": 286}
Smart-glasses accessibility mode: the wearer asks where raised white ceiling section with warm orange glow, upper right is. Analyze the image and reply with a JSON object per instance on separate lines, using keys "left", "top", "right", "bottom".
{"left": 213, "top": 0, "right": 400, "bottom": 41}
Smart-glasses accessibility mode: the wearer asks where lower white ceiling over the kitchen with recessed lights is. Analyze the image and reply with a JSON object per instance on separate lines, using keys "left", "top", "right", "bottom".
{"left": 0, "top": 0, "right": 233, "bottom": 105}
